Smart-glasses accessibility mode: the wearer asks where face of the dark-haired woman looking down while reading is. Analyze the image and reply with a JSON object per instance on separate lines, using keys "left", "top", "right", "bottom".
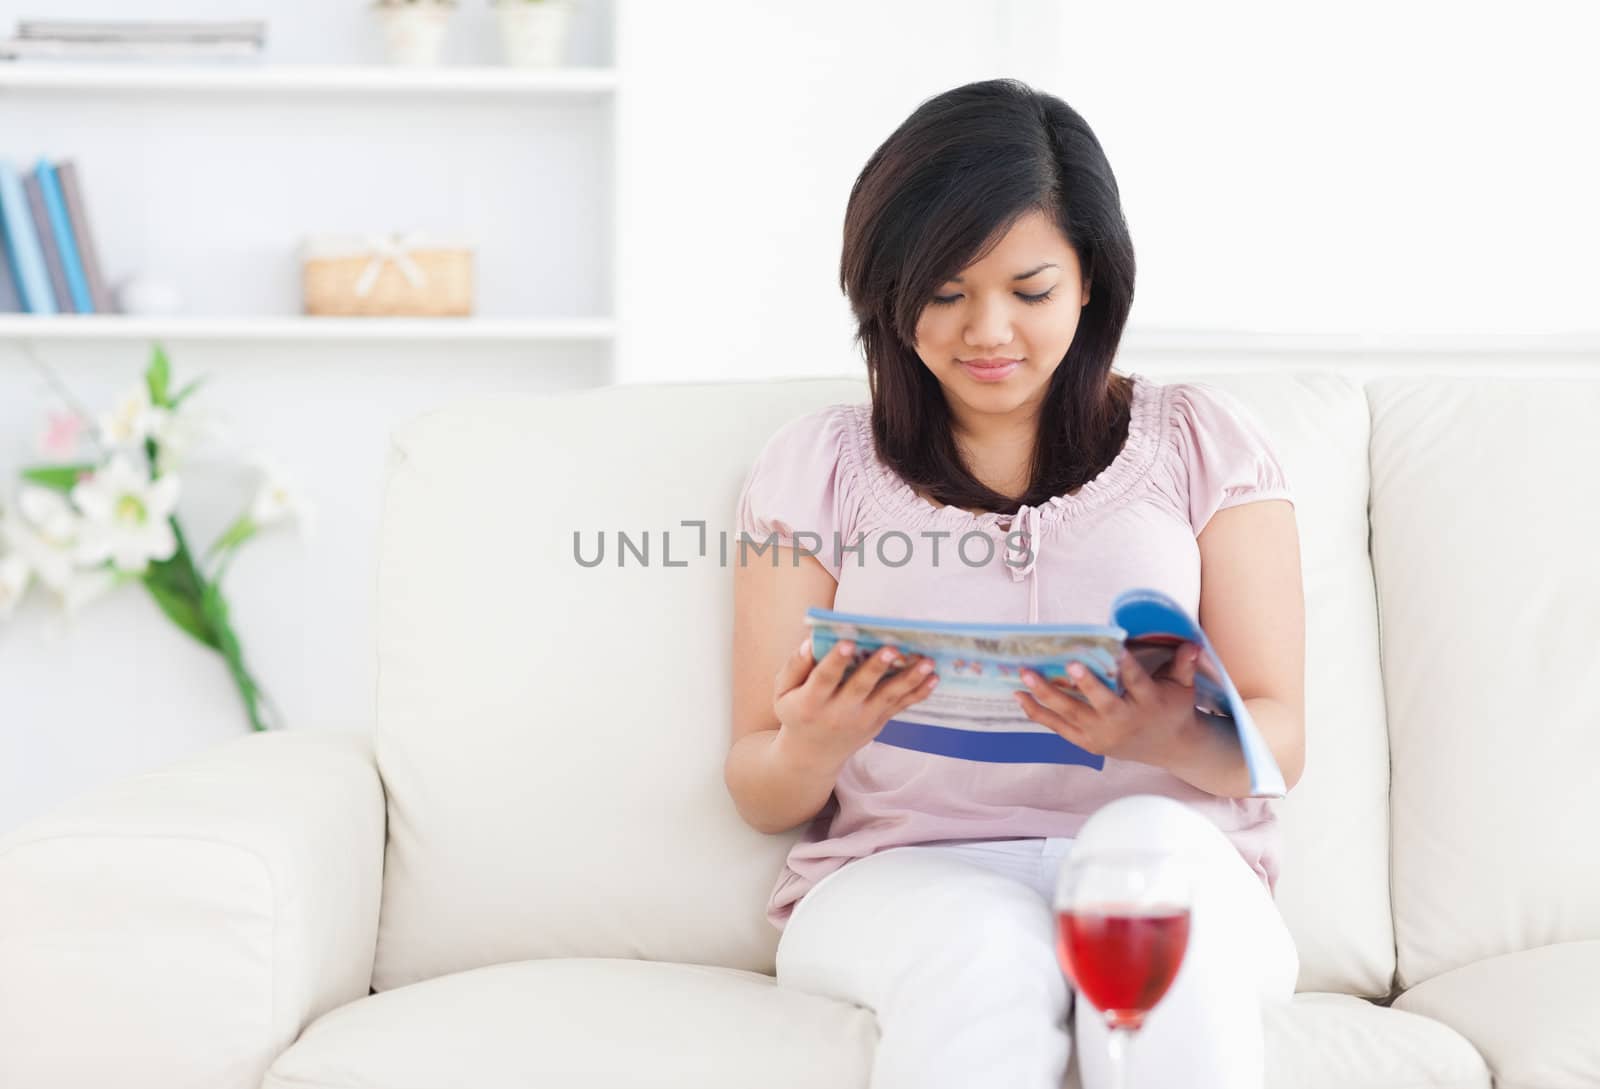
{"left": 915, "top": 211, "right": 1090, "bottom": 429}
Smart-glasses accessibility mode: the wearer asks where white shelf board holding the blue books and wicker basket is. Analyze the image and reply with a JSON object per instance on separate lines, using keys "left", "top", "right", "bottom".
{"left": 0, "top": 313, "right": 616, "bottom": 342}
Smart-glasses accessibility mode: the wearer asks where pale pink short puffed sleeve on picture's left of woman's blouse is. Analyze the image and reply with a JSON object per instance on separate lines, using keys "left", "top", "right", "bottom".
{"left": 738, "top": 405, "right": 859, "bottom": 580}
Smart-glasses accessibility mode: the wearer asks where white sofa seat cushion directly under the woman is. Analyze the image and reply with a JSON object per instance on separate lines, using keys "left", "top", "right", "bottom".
{"left": 262, "top": 958, "right": 1490, "bottom": 1089}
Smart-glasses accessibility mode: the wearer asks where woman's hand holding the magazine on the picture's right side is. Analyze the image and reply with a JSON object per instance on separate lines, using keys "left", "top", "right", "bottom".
{"left": 1016, "top": 643, "right": 1200, "bottom": 768}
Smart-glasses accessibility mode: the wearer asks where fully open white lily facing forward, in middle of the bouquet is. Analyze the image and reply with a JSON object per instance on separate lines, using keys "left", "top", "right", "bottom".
{"left": 72, "top": 454, "right": 178, "bottom": 572}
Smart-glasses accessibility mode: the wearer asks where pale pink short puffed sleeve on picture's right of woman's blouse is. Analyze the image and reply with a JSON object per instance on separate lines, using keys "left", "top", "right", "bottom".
{"left": 1170, "top": 382, "right": 1294, "bottom": 537}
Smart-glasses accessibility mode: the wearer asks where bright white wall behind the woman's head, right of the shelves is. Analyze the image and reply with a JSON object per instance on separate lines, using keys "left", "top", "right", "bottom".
{"left": 621, "top": 0, "right": 1600, "bottom": 381}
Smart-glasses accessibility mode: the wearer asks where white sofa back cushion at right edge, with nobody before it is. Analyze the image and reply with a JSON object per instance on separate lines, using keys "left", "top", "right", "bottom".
{"left": 1366, "top": 376, "right": 1600, "bottom": 987}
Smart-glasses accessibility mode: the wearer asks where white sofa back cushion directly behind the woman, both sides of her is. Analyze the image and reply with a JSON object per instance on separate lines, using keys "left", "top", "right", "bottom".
{"left": 374, "top": 367, "right": 1394, "bottom": 995}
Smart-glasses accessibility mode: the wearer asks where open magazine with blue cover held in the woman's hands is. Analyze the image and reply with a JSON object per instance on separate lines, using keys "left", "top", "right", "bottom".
{"left": 805, "top": 588, "right": 1288, "bottom": 798}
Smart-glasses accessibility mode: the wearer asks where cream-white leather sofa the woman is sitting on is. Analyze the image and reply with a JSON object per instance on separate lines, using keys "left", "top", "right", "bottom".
{"left": 0, "top": 371, "right": 1600, "bottom": 1089}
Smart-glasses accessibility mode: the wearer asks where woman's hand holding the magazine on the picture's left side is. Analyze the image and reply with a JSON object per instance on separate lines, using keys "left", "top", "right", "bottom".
{"left": 773, "top": 636, "right": 939, "bottom": 769}
